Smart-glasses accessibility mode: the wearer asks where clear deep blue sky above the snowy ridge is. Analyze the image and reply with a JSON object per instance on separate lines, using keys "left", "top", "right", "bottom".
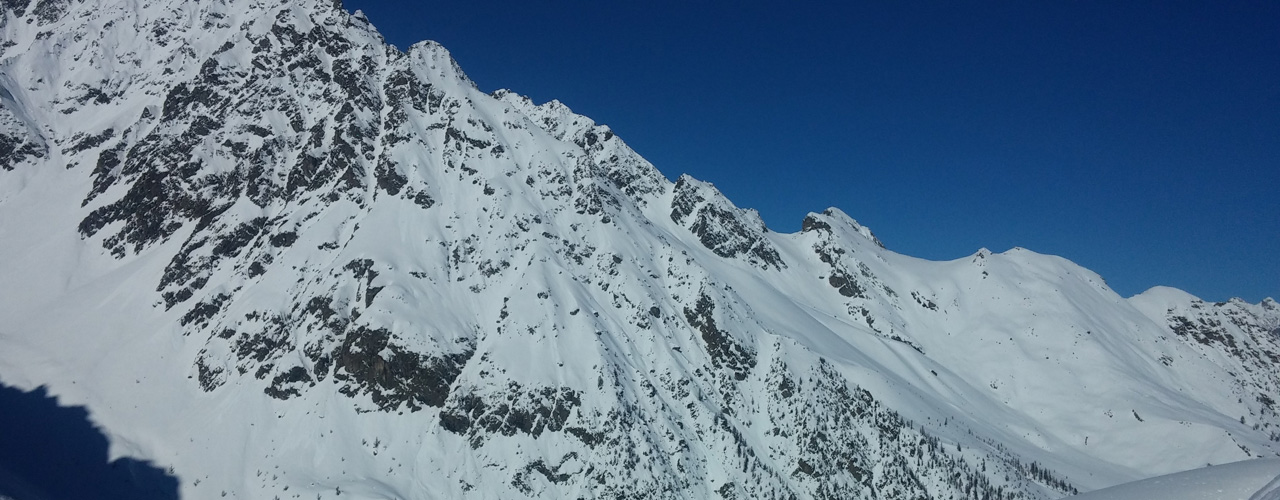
{"left": 344, "top": 0, "right": 1280, "bottom": 302}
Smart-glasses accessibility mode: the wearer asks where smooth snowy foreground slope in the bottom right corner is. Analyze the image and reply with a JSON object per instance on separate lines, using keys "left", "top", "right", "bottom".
{"left": 1071, "top": 458, "right": 1280, "bottom": 500}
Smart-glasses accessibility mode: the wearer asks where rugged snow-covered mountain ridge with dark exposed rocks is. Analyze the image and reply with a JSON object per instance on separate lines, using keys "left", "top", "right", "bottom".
{"left": 0, "top": 0, "right": 1280, "bottom": 499}
